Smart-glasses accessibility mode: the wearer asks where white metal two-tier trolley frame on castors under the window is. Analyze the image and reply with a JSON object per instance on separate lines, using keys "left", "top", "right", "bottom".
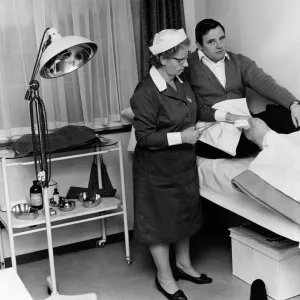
{"left": 0, "top": 136, "right": 131, "bottom": 272}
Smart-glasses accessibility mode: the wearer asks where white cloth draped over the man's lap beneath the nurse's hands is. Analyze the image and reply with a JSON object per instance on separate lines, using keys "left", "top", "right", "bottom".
{"left": 197, "top": 98, "right": 251, "bottom": 156}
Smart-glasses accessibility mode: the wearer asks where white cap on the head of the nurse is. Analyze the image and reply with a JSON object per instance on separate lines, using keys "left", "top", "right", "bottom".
{"left": 149, "top": 28, "right": 187, "bottom": 55}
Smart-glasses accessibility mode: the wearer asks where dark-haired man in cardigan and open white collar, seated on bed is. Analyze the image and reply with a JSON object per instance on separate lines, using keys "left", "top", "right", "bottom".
{"left": 185, "top": 19, "right": 300, "bottom": 158}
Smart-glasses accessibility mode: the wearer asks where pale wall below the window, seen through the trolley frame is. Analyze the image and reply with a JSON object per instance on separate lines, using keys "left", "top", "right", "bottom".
{"left": 0, "top": 132, "right": 133, "bottom": 257}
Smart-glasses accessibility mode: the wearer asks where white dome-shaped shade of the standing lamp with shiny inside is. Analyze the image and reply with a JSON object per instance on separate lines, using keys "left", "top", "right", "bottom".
{"left": 40, "top": 28, "right": 98, "bottom": 78}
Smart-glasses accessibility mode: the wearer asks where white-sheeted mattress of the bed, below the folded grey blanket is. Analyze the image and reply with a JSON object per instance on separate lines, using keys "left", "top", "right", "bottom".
{"left": 197, "top": 157, "right": 300, "bottom": 242}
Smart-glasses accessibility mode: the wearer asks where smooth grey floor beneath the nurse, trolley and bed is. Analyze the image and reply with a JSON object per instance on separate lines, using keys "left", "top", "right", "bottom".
{"left": 18, "top": 230, "right": 300, "bottom": 300}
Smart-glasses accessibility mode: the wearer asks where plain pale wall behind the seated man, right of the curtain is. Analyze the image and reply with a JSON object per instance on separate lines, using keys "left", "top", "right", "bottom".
{"left": 186, "top": 0, "right": 300, "bottom": 112}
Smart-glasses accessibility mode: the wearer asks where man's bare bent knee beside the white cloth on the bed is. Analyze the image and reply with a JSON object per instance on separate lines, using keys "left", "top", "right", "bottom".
{"left": 244, "top": 118, "right": 271, "bottom": 149}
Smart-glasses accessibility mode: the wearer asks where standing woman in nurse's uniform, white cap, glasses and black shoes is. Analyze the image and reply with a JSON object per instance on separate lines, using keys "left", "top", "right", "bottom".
{"left": 130, "top": 29, "right": 215, "bottom": 300}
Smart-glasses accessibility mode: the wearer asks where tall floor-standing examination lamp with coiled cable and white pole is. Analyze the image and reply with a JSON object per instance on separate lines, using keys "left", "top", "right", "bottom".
{"left": 25, "top": 28, "right": 98, "bottom": 300}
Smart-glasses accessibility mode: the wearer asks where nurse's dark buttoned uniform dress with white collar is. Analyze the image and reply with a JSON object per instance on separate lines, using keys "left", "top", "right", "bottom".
{"left": 130, "top": 67, "right": 213, "bottom": 243}
